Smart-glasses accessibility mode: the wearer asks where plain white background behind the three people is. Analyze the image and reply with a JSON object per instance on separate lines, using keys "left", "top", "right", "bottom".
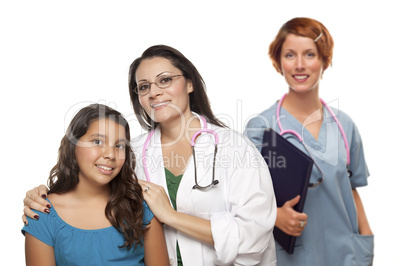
{"left": 0, "top": 0, "right": 402, "bottom": 265}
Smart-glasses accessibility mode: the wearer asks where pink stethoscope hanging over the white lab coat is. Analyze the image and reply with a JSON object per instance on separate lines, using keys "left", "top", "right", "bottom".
{"left": 142, "top": 115, "right": 219, "bottom": 190}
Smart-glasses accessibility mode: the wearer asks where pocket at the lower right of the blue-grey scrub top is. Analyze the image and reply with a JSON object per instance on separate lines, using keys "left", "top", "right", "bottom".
{"left": 352, "top": 234, "right": 374, "bottom": 266}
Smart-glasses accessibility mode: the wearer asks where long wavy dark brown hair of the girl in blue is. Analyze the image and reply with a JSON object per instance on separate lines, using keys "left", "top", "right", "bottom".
{"left": 48, "top": 104, "right": 146, "bottom": 249}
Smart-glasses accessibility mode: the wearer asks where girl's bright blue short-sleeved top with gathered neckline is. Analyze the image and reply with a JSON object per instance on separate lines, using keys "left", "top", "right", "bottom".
{"left": 22, "top": 200, "right": 154, "bottom": 265}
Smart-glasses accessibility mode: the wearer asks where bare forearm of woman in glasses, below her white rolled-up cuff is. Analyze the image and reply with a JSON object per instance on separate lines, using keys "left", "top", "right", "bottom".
{"left": 165, "top": 211, "right": 214, "bottom": 246}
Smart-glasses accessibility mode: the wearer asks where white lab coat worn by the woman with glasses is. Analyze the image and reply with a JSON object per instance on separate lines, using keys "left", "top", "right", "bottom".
{"left": 133, "top": 117, "right": 276, "bottom": 266}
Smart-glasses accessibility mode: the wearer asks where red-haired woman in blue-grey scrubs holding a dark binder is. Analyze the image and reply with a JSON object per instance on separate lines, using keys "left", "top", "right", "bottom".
{"left": 245, "top": 18, "right": 374, "bottom": 266}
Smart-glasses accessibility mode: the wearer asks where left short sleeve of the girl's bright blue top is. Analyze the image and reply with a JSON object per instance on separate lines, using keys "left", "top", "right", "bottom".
{"left": 21, "top": 209, "right": 55, "bottom": 247}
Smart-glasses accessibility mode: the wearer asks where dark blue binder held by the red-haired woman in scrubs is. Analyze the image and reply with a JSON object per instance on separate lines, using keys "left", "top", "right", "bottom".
{"left": 261, "top": 129, "right": 314, "bottom": 254}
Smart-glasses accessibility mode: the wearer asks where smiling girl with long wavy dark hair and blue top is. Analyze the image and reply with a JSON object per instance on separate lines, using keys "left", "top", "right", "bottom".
{"left": 22, "top": 104, "right": 168, "bottom": 266}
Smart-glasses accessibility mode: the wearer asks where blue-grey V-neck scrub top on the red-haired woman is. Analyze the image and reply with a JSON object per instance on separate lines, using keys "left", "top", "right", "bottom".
{"left": 244, "top": 103, "right": 374, "bottom": 266}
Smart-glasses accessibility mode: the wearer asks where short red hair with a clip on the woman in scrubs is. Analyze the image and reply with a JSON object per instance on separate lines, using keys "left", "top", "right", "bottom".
{"left": 268, "top": 18, "right": 334, "bottom": 73}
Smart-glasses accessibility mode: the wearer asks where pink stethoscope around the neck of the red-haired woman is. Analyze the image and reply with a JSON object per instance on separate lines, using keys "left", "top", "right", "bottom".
{"left": 276, "top": 93, "right": 352, "bottom": 188}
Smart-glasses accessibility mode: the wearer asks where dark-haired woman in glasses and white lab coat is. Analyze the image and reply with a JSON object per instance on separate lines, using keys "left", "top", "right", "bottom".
{"left": 24, "top": 45, "right": 276, "bottom": 266}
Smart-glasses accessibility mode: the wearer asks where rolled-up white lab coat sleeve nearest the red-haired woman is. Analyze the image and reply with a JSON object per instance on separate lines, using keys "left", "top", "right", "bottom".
{"left": 211, "top": 138, "right": 276, "bottom": 265}
